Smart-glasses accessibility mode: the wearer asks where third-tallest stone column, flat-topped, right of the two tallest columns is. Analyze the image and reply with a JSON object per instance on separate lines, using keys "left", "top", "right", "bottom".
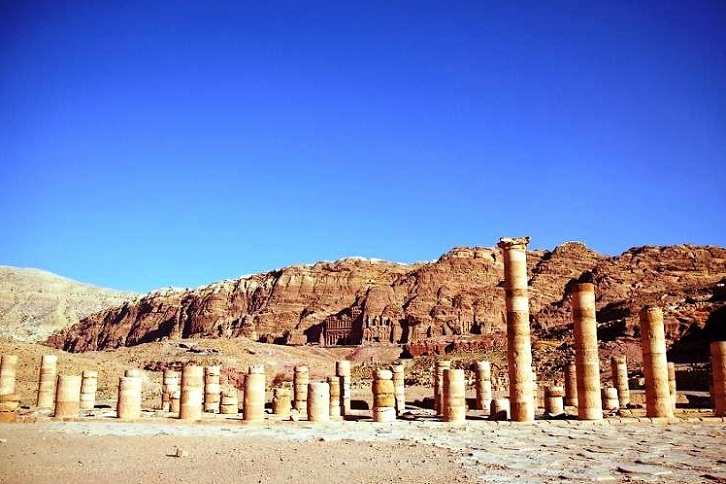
{"left": 640, "top": 306, "right": 673, "bottom": 417}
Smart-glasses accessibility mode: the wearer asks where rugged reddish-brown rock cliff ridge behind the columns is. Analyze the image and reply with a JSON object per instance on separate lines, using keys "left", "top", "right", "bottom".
{"left": 47, "top": 242, "right": 726, "bottom": 352}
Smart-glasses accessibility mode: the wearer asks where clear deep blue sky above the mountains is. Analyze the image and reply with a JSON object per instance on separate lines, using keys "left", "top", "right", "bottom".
{"left": 0, "top": 0, "right": 726, "bottom": 291}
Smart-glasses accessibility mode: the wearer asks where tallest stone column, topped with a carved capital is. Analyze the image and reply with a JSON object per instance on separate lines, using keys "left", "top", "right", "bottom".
{"left": 498, "top": 237, "right": 534, "bottom": 422}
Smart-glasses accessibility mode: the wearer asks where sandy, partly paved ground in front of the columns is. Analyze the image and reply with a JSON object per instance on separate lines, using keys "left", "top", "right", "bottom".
{"left": 0, "top": 412, "right": 726, "bottom": 484}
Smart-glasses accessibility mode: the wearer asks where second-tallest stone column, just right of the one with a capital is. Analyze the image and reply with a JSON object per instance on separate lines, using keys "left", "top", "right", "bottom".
{"left": 572, "top": 282, "right": 602, "bottom": 420}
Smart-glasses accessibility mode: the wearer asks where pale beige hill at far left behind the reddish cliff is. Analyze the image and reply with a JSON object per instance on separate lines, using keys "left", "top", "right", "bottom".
{"left": 0, "top": 266, "right": 136, "bottom": 342}
